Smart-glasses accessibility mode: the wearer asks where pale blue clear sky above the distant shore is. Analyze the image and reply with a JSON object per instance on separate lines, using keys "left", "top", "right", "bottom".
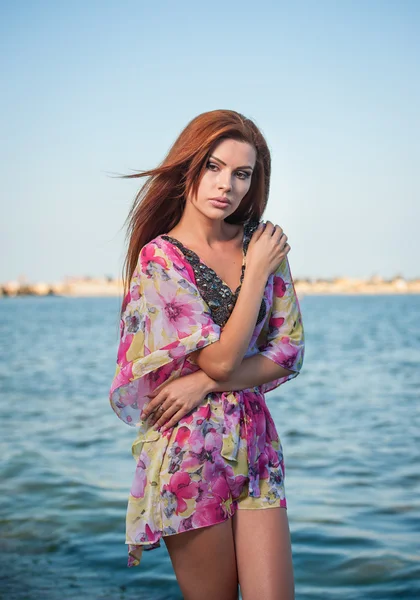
{"left": 0, "top": 0, "right": 420, "bottom": 283}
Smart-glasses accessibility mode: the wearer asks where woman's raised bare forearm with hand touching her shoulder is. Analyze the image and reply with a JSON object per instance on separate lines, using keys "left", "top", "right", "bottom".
{"left": 193, "top": 221, "right": 290, "bottom": 381}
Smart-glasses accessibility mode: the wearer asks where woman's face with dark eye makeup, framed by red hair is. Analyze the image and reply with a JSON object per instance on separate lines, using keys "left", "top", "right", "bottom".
{"left": 192, "top": 139, "right": 257, "bottom": 220}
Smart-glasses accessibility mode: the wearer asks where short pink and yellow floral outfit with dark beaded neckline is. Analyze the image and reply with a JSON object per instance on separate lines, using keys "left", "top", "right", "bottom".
{"left": 109, "top": 221, "right": 304, "bottom": 566}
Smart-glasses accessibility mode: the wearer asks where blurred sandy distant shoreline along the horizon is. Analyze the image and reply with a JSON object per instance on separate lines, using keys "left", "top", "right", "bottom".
{"left": 0, "top": 276, "right": 420, "bottom": 298}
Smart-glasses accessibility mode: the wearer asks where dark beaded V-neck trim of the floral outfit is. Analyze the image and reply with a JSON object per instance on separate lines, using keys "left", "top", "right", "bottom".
{"left": 160, "top": 220, "right": 267, "bottom": 327}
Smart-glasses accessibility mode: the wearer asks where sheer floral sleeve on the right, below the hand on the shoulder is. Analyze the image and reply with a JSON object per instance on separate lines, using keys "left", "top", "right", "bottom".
{"left": 259, "top": 255, "right": 305, "bottom": 393}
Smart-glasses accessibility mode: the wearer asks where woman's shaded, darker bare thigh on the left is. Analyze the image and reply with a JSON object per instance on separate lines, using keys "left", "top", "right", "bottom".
{"left": 163, "top": 518, "right": 238, "bottom": 600}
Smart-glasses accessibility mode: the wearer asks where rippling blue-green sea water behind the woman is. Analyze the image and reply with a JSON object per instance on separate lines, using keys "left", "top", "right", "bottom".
{"left": 0, "top": 296, "right": 420, "bottom": 600}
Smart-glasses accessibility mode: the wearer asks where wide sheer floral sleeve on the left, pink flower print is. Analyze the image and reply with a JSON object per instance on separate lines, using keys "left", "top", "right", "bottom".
{"left": 109, "top": 240, "right": 221, "bottom": 427}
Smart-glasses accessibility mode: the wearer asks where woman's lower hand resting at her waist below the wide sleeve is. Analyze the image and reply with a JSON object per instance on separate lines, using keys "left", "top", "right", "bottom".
{"left": 141, "top": 372, "right": 209, "bottom": 432}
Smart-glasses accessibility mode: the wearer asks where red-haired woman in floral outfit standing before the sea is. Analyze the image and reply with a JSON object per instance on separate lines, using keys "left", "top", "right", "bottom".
{"left": 110, "top": 110, "right": 304, "bottom": 600}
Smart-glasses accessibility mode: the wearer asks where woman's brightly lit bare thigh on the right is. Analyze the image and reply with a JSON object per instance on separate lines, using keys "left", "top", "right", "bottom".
{"left": 233, "top": 507, "right": 294, "bottom": 600}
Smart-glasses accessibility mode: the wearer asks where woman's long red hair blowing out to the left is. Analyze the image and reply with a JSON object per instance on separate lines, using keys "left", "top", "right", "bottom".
{"left": 117, "top": 110, "right": 271, "bottom": 313}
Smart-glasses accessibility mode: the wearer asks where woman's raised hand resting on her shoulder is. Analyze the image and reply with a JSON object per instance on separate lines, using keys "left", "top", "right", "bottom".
{"left": 246, "top": 221, "right": 290, "bottom": 278}
